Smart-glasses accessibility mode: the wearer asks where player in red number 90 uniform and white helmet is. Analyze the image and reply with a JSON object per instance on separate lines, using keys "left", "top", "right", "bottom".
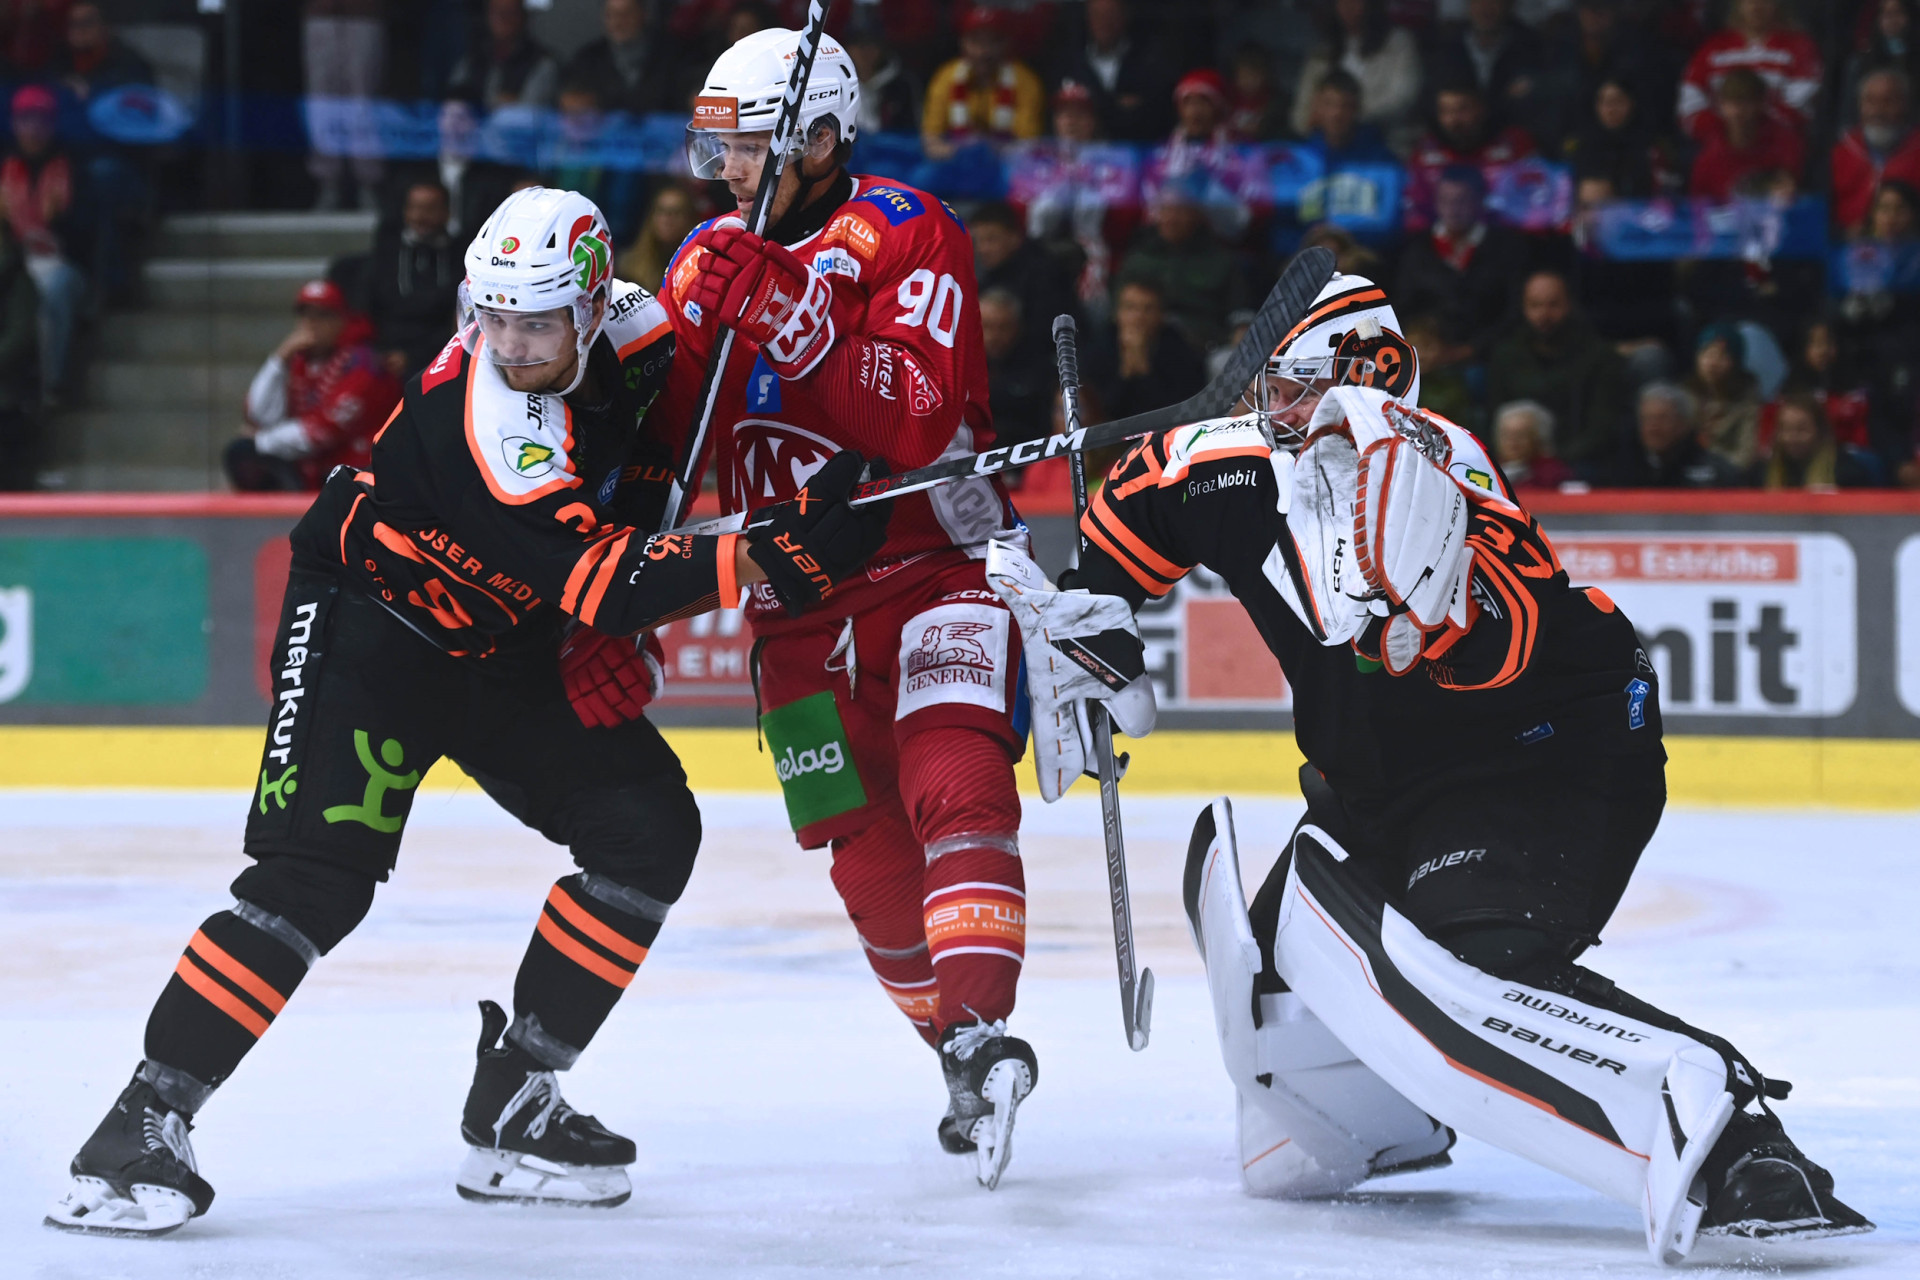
{"left": 662, "top": 29, "right": 1035, "bottom": 1186}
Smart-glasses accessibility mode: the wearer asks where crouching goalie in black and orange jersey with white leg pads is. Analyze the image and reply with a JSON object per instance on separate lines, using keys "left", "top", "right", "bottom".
{"left": 989, "top": 274, "right": 1872, "bottom": 1263}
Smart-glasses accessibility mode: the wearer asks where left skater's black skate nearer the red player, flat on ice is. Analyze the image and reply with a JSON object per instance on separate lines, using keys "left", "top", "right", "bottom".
{"left": 455, "top": 1000, "right": 636, "bottom": 1209}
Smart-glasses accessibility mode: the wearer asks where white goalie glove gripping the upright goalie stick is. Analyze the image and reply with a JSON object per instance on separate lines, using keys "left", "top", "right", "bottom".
{"left": 987, "top": 539, "right": 1156, "bottom": 804}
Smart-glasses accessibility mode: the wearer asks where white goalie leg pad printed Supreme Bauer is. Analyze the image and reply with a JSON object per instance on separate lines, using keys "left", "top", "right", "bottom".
{"left": 1273, "top": 825, "right": 1734, "bottom": 1263}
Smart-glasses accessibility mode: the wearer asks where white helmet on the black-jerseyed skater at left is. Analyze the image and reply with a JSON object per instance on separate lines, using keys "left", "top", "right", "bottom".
{"left": 461, "top": 186, "right": 612, "bottom": 395}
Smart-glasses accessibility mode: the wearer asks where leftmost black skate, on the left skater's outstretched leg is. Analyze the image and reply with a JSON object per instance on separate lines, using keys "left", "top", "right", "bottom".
{"left": 46, "top": 1073, "right": 213, "bottom": 1236}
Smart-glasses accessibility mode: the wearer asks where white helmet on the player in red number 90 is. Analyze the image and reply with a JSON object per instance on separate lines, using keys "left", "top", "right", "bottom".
{"left": 687, "top": 27, "right": 860, "bottom": 178}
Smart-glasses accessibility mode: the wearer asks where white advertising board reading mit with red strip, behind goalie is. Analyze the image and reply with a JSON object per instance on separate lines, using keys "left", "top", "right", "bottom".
{"left": 1553, "top": 533, "right": 1859, "bottom": 723}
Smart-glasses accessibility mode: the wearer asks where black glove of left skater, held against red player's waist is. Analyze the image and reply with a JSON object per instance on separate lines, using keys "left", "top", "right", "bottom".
{"left": 747, "top": 449, "right": 893, "bottom": 618}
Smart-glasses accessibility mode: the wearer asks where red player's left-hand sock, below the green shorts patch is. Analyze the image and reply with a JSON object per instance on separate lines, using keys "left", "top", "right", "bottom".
{"left": 833, "top": 808, "right": 941, "bottom": 1044}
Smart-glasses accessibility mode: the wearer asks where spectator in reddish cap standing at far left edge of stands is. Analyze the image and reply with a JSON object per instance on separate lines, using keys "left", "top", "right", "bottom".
{"left": 0, "top": 84, "right": 86, "bottom": 405}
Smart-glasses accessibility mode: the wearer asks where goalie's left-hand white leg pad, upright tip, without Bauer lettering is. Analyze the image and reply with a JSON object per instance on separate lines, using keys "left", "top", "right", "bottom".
{"left": 1188, "top": 796, "right": 1453, "bottom": 1197}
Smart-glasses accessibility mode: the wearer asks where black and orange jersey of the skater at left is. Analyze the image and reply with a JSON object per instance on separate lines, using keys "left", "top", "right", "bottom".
{"left": 294, "top": 282, "right": 739, "bottom": 662}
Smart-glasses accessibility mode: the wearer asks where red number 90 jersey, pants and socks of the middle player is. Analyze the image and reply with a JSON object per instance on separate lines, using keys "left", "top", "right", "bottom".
{"left": 660, "top": 175, "right": 1025, "bottom": 1040}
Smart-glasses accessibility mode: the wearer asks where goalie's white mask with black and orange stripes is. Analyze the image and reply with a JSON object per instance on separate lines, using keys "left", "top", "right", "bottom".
{"left": 1256, "top": 273, "right": 1421, "bottom": 443}
